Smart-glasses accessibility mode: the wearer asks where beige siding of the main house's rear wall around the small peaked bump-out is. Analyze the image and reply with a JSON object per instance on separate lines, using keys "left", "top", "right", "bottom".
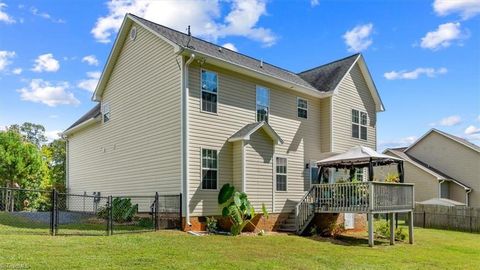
{"left": 189, "top": 62, "right": 321, "bottom": 215}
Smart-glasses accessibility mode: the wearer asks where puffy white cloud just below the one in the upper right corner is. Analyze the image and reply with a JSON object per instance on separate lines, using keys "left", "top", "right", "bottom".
{"left": 420, "top": 22, "right": 465, "bottom": 50}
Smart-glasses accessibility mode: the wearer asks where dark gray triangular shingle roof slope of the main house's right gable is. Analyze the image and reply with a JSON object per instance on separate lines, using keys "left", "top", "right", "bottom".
{"left": 298, "top": 53, "right": 359, "bottom": 92}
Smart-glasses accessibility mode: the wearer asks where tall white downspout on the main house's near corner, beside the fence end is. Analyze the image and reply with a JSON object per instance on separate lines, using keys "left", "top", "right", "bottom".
{"left": 182, "top": 53, "right": 195, "bottom": 226}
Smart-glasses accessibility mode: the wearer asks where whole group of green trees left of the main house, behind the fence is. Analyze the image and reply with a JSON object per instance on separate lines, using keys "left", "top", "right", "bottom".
{"left": 0, "top": 122, "right": 66, "bottom": 191}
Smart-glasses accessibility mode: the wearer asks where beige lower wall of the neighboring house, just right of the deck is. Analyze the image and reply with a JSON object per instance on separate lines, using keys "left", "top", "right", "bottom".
{"left": 386, "top": 151, "right": 439, "bottom": 202}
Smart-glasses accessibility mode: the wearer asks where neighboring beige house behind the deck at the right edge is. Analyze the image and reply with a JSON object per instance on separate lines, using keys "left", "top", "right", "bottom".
{"left": 384, "top": 129, "right": 480, "bottom": 207}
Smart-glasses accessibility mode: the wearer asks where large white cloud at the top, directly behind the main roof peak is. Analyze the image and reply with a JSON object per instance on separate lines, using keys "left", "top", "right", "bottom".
{"left": 91, "top": 0, "right": 277, "bottom": 46}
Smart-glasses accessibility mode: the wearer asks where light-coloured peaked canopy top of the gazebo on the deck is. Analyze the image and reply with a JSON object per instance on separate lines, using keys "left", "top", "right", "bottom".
{"left": 317, "top": 146, "right": 402, "bottom": 166}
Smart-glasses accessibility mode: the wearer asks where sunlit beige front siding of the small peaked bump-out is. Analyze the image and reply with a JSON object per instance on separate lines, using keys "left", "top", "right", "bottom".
{"left": 245, "top": 129, "right": 274, "bottom": 212}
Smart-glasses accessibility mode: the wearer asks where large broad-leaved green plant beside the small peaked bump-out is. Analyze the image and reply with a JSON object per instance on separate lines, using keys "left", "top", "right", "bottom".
{"left": 218, "top": 183, "right": 256, "bottom": 235}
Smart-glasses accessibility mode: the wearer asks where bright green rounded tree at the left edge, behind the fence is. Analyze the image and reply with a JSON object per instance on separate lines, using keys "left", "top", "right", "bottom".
{"left": 0, "top": 130, "right": 48, "bottom": 188}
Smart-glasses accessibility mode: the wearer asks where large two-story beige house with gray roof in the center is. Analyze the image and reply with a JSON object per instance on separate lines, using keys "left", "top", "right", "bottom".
{"left": 64, "top": 14, "right": 384, "bottom": 229}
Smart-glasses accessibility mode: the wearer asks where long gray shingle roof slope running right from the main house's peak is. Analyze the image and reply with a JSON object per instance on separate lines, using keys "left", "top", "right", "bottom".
{"left": 130, "top": 14, "right": 344, "bottom": 92}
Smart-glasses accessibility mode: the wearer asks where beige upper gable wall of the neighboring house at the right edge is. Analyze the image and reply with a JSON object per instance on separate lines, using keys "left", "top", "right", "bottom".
{"left": 408, "top": 132, "right": 480, "bottom": 207}
